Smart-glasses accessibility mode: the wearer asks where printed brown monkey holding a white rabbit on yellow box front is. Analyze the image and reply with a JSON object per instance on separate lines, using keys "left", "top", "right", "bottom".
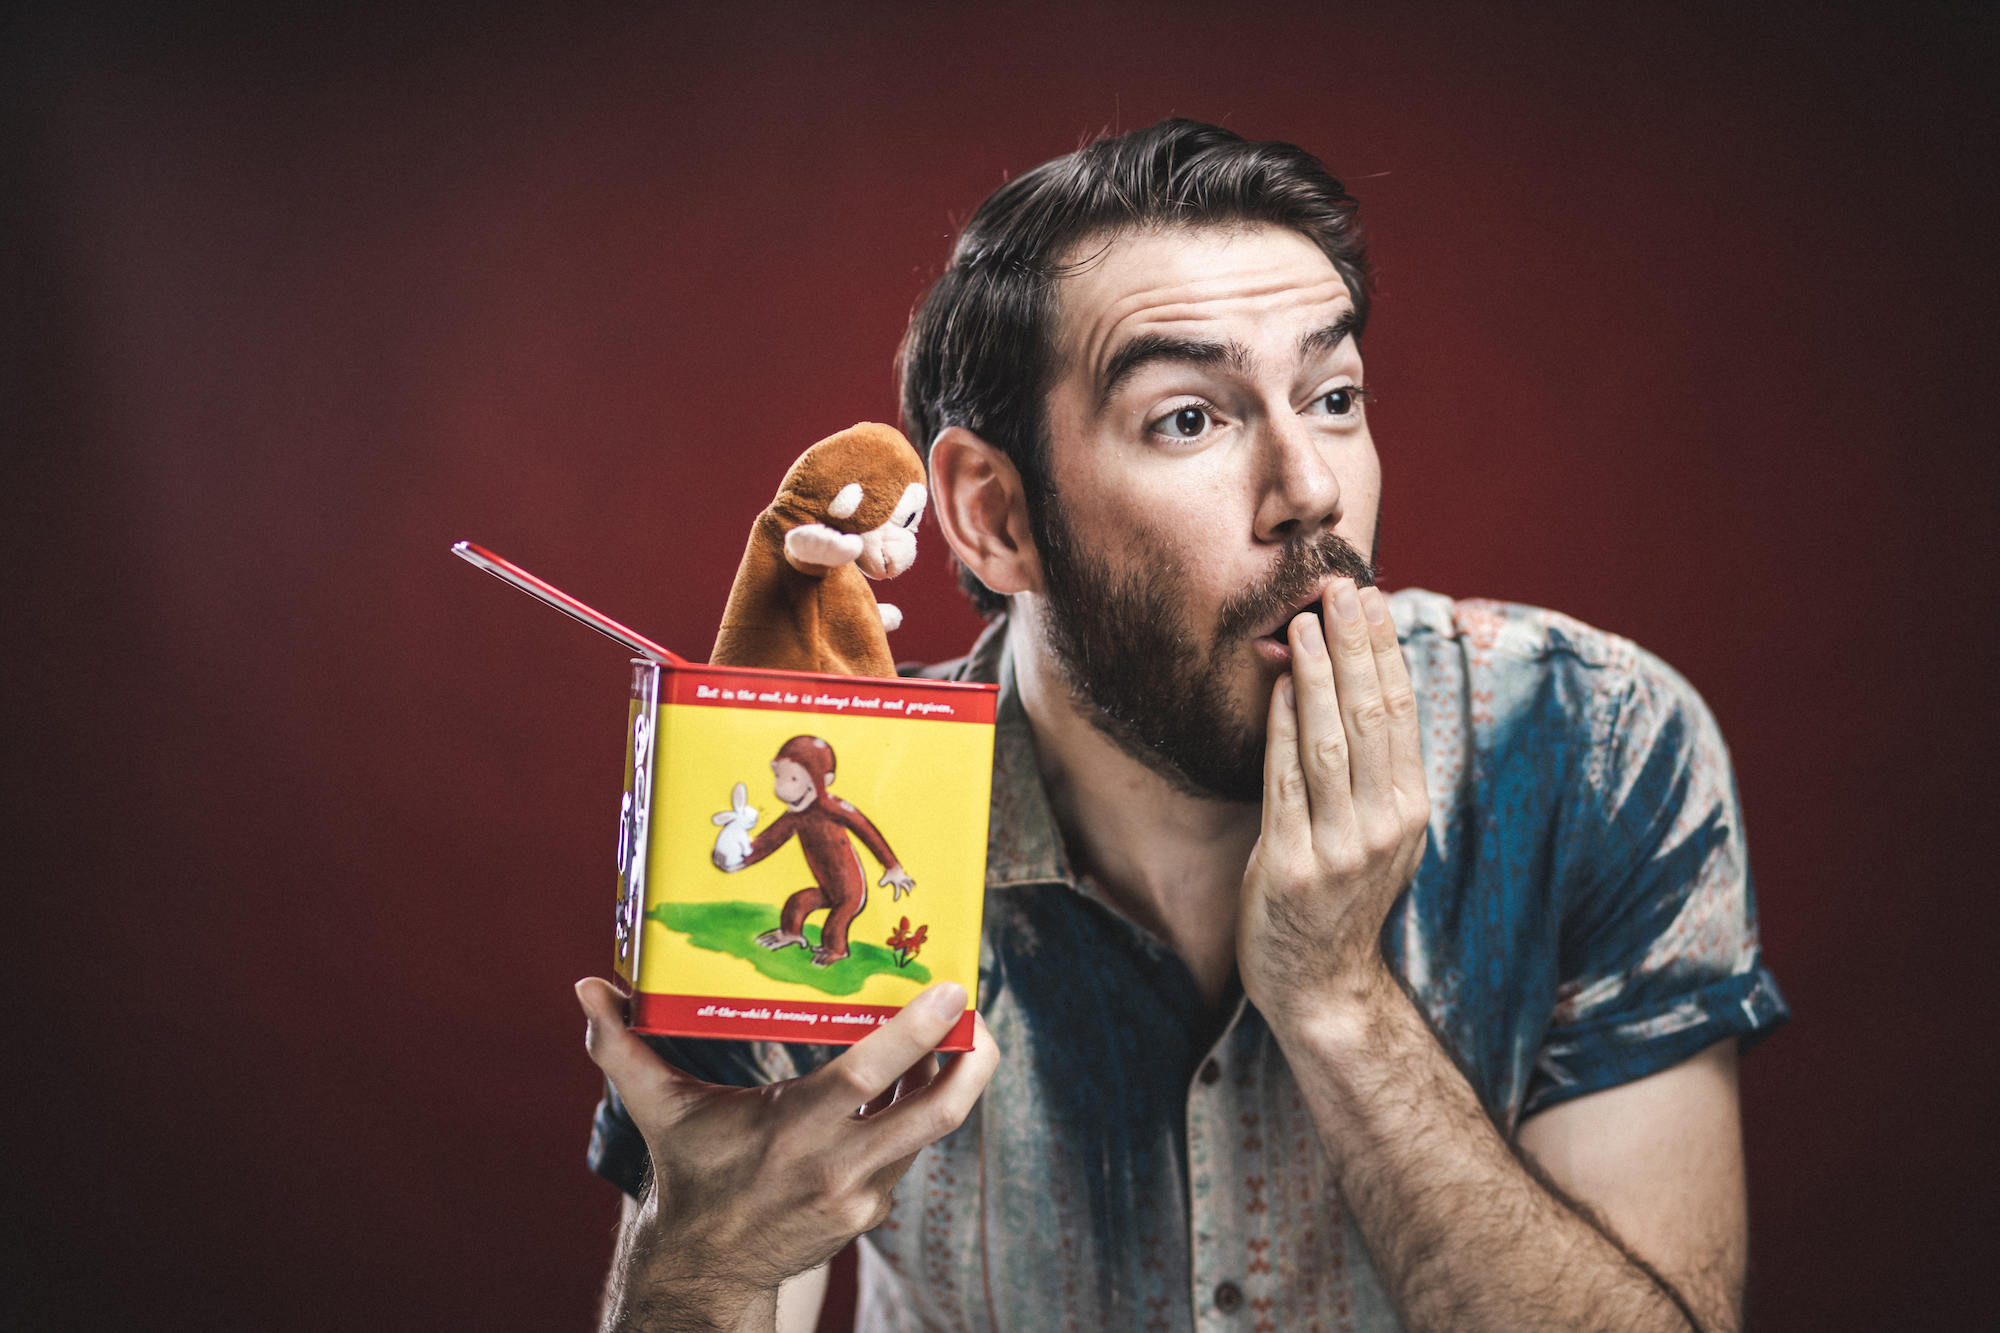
{"left": 710, "top": 737, "right": 916, "bottom": 967}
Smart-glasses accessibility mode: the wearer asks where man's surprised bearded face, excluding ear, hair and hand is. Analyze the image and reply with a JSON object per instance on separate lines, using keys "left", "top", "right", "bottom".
{"left": 1038, "top": 226, "right": 1382, "bottom": 801}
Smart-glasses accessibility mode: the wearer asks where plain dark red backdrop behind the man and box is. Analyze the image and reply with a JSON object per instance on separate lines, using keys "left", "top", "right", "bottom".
{"left": 0, "top": 4, "right": 2000, "bottom": 1329}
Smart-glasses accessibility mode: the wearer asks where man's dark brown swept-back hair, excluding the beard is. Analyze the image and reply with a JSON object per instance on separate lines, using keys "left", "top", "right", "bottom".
{"left": 898, "top": 120, "right": 1368, "bottom": 616}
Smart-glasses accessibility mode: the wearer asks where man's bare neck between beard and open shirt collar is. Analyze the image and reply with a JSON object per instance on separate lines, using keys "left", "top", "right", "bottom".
{"left": 1008, "top": 596, "right": 1258, "bottom": 1007}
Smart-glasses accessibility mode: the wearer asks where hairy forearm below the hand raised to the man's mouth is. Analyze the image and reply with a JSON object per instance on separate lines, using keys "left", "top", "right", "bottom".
{"left": 1274, "top": 969, "right": 1716, "bottom": 1333}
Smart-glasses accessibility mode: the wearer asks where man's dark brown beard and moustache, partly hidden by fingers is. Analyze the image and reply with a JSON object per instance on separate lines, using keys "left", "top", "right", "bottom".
{"left": 1038, "top": 494, "right": 1374, "bottom": 801}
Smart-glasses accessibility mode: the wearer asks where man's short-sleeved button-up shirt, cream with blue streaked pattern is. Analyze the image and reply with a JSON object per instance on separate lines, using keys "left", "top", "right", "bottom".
{"left": 590, "top": 590, "right": 1788, "bottom": 1333}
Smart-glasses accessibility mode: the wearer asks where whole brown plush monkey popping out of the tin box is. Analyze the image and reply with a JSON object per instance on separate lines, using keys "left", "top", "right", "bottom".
{"left": 708, "top": 422, "right": 930, "bottom": 677}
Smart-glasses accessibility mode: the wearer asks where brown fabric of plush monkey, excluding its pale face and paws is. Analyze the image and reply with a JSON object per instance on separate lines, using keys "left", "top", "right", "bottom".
{"left": 708, "top": 422, "right": 924, "bottom": 677}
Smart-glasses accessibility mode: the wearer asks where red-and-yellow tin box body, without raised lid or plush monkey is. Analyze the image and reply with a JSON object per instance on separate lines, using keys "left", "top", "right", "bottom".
{"left": 600, "top": 664, "right": 994, "bottom": 1049}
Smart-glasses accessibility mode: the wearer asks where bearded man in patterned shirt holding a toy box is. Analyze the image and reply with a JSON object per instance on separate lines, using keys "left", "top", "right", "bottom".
{"left": 580, "top": 122, "right": 1784, "bottom": 1333}
